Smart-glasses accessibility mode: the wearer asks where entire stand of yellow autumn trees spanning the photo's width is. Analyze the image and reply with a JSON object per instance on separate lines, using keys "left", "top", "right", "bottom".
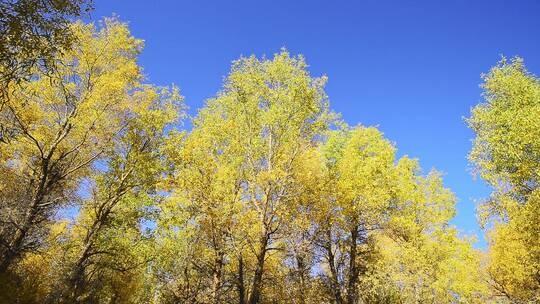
{"left": 0, "top": 10, "right": 540, "bottom": 304}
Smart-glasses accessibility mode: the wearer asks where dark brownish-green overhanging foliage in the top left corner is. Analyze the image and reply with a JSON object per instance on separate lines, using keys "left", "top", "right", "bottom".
{"left": 0, "top": 0, "right": 92, "bottom": 95}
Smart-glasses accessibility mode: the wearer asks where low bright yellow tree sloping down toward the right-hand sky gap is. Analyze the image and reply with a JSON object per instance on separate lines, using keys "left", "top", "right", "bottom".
{"left": 361, "top": 157, "right": 486, "bottom": 303}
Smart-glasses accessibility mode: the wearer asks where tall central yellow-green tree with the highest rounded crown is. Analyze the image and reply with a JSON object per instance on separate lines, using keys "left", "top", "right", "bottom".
{"left": 158, "top": 51, "right": 331, "bottom": 303}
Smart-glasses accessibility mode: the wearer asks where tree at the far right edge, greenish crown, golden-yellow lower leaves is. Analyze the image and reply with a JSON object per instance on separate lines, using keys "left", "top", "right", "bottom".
{"left": 467, "top": 58, "right": 540, "bottom": 303}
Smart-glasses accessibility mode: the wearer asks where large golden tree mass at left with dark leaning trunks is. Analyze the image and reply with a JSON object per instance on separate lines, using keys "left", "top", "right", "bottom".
{"left": 0, "top": 19, "right": 183, "bottom": 303}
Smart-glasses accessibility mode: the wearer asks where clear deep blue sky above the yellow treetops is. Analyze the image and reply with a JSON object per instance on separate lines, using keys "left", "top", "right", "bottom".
{"left": 86, "top": 0, "right": 540, "bottom": 248}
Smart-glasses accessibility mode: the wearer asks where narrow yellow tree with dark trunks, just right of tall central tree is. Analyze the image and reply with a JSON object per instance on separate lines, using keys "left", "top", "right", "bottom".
{"left": 319, "top": 127, "right": 402, "bottom": 304}
